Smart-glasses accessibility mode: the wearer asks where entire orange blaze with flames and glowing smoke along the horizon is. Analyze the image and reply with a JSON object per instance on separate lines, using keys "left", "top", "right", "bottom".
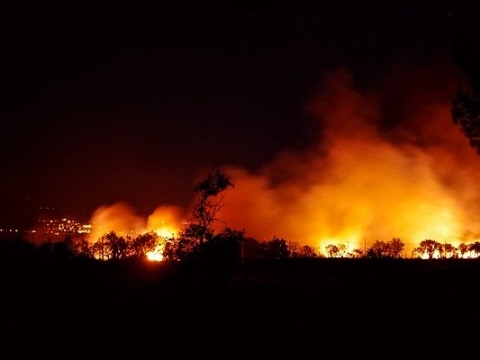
{"left": 8, "top": 58, "right": 480, "bottom": 260}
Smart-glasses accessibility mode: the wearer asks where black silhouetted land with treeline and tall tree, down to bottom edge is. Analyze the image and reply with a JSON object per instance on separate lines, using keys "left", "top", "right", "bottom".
{"left": 0, "top": 173, "right": 480, "bottom": 359}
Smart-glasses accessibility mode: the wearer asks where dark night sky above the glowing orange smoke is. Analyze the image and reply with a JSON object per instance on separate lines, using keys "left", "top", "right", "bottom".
{"left": 0, "top": 1, "right": 480, "bottom": 226}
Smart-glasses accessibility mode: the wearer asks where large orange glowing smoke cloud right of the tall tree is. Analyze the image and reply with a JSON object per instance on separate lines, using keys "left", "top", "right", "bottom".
{"left": 215, "top": 64, "right": 480, "bottom": 255}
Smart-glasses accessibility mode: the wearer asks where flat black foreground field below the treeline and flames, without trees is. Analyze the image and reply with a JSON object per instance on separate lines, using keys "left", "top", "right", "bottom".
{"left": 0, "top": 259, "right": 480, "bottom": 359}
